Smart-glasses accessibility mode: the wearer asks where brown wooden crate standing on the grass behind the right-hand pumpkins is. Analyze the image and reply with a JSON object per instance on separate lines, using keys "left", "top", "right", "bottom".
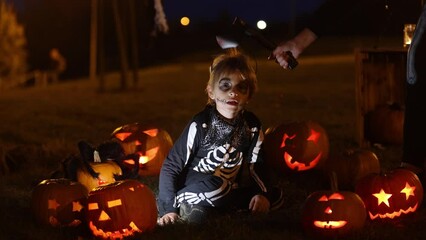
{"left": 355, "top": 48, "right": 407, "bottom": 147}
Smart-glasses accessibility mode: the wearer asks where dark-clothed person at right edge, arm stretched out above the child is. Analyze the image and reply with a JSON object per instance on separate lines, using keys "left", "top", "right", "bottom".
{"left": 270, "top": 0, "right": 426, "bottom": 182}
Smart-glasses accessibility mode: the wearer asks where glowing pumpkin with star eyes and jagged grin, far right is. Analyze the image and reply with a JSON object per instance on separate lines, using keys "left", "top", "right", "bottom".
{"left": 355, "top": 168, "right": 423, "bottom": 220}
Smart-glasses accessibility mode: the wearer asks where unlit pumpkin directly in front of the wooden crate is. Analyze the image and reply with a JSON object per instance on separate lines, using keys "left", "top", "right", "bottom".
{"left": 365, "top": 103, "right": 404, "bottom": 145}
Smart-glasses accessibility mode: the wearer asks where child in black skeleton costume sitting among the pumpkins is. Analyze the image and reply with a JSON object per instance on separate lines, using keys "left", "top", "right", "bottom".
{"left": 158, "top": 52, "right": 282, "bottom": 225}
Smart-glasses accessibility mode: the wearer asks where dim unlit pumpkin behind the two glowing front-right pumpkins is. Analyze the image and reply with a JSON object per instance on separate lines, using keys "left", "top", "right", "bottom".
{"left": 325, "top": 149, "right": 380, "bottom": 190}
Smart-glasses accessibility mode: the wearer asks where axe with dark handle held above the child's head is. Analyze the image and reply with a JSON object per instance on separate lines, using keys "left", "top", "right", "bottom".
{"left": 216, "top": 17, "right": 299, "bottom": 69}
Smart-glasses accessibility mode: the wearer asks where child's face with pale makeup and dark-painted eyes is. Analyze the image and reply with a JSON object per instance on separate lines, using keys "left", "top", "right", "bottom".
{"left": 207, "top": 72, "right": 250, "bottom": 119}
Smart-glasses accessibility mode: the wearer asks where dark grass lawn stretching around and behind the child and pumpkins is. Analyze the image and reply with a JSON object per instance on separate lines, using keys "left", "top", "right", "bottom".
{"left": 0, "top": 34, "right": 426, "bottom": 240}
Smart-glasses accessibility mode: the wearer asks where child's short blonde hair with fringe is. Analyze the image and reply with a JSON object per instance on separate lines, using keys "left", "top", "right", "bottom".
{"left": 206, "top": 51, "right": 257, "bottom": 105}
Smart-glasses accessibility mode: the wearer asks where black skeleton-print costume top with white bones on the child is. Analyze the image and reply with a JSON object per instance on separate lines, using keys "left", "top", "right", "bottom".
{"left": 158, "top": 106, "right": 266, "bottom": 216}
